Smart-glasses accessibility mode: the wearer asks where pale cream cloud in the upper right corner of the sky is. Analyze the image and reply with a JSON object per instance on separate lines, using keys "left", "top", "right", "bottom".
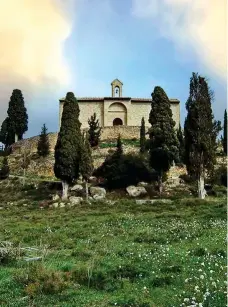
{"left": 132, "top": 0, "right": 227, "bottom": 80}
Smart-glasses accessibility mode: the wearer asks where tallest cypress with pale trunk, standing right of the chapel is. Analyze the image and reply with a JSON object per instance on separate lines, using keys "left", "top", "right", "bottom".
{"left": 184, "top": 73, "right": 221, "bottom": 199}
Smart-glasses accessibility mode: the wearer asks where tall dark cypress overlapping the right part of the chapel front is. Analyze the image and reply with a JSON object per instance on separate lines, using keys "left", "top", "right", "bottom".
{"left": 149, "top": 86, "right": 178, "bottom": 193}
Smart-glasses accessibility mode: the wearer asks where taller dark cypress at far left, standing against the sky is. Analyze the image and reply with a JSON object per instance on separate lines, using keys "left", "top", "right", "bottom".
{"left": 7, "top": 89, "right": 28, "bottom": 142}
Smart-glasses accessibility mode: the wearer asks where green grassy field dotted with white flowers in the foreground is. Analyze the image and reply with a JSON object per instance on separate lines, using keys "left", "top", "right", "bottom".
{"left": 0, "top": 184, "right": 227, "bottom": 307}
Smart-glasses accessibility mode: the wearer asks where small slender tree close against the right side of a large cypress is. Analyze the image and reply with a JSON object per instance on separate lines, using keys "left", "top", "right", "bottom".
{"left": 80, "top": 134, "right": 93, "bottom": 200}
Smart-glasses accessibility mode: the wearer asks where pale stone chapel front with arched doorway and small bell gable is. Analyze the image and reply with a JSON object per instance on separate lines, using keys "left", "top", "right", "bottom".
{"left": 59, "top": 79, "right": 180, "bottom": 128}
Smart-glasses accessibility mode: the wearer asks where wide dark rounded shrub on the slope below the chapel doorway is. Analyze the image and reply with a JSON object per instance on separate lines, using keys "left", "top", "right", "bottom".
{"left": 94, "top": 153, "right": 157, "bottom": 188}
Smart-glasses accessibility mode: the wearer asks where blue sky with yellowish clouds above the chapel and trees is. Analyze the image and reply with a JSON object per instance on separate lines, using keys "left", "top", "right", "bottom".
{"left": 0, "top": 0, "right": 227, "bottom": 137}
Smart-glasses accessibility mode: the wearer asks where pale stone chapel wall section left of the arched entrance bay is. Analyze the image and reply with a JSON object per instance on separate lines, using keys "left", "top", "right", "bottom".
{"left": 59, "top": 101, "right": 104, "bottom": 128}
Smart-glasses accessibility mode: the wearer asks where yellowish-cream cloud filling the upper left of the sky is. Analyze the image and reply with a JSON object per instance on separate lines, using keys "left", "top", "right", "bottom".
{"left": 0, "top": 0, "right": 73, "bottom": 124}
